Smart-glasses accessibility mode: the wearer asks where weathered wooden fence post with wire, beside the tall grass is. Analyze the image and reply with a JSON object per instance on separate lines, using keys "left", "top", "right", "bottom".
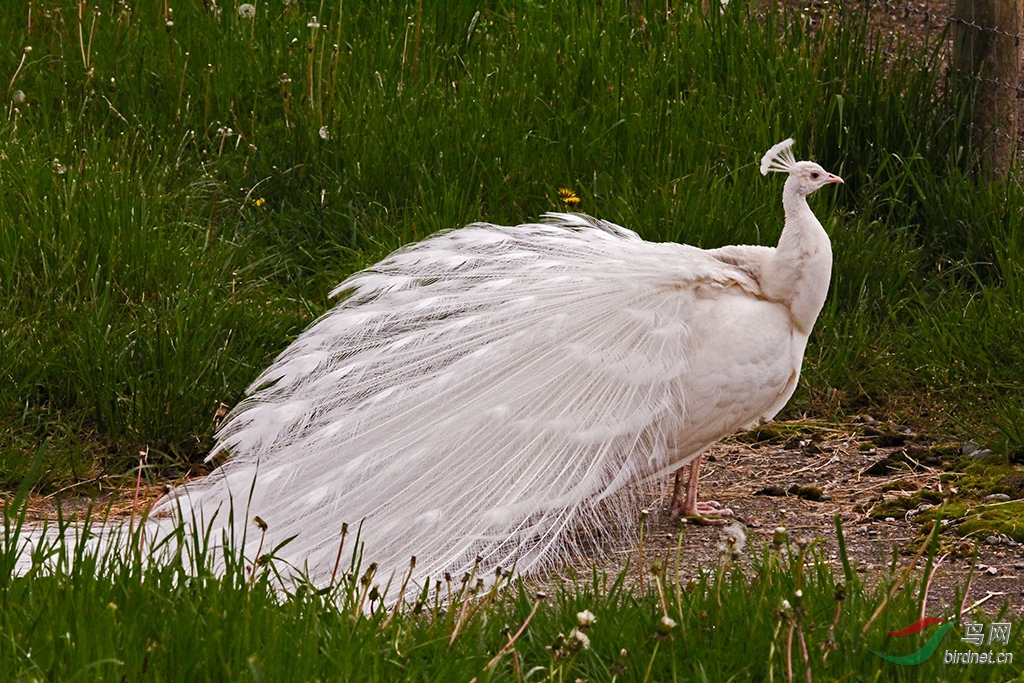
{"left": 953, "top": 0, "right": 1024, "bottom": 178}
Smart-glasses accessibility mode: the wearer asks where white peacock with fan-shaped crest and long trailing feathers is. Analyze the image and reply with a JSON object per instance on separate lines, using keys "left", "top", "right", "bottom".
{"left": 51, "top": 140, "right": 841, "bottom": 598}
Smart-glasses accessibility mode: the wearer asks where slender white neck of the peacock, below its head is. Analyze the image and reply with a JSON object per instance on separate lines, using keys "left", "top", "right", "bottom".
{"left": 761, "top": 182, "right": 831, "bottom": 335}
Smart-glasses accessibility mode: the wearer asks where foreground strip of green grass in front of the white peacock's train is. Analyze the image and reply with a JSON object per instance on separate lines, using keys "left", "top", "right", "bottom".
{"left": 0, "top": 499, "right": 1024, "bottom": 682}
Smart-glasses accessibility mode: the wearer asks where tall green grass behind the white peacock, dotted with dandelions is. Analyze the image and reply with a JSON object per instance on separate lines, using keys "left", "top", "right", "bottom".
{"left": 0, "top": 0, "right": 1024, "bottom": 481}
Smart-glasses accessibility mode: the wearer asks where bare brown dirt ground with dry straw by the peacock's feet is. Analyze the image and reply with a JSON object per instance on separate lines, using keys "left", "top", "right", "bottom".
{"left": 581, "top": 423, "right": 1024, "bottom": 617}
